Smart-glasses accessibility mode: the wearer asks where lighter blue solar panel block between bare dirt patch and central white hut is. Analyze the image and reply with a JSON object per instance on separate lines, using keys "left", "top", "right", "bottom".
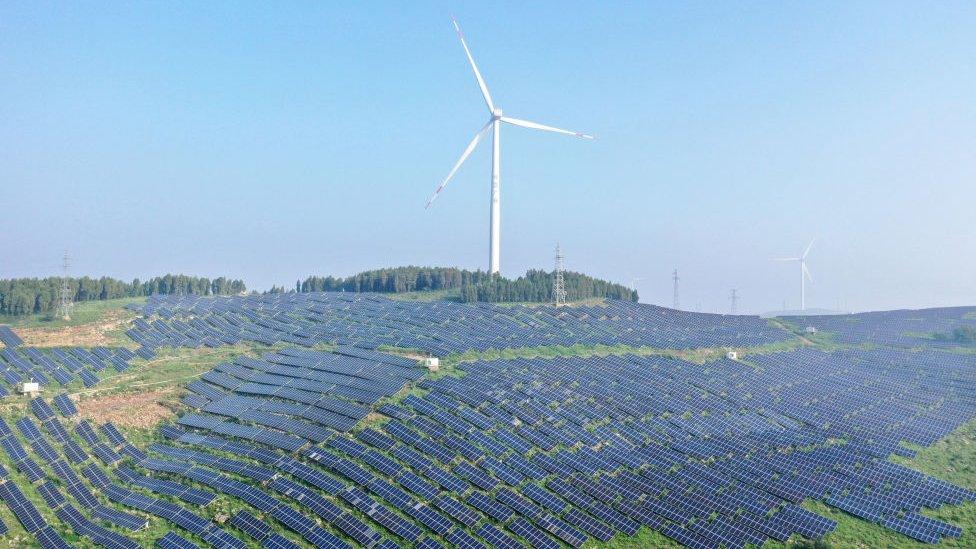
{"left": 179, "top": 347, "right": 425, "bottom": 451}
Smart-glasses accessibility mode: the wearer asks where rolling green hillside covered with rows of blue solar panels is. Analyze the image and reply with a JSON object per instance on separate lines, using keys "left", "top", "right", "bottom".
{"left": 0, "top": 292, "right": 976, "bottom": 549}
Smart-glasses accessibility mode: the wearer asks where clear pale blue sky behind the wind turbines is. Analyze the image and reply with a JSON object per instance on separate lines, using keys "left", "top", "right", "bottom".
{"left": 0, "top": 1, "right": 976, "bottom": 313}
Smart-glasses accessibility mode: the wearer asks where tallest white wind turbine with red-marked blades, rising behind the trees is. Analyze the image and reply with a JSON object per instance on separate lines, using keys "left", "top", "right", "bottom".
{"left": 427, "top": 18, "right": 593, "bottom": 274}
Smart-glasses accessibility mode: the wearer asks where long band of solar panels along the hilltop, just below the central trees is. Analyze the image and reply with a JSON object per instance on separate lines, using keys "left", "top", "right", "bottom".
{"left": 127, "top": 292, "right": 792, "bottom": 356}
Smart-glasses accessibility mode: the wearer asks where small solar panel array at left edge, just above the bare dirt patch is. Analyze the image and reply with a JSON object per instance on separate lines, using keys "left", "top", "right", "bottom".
{"left": 0, "top": 347, "right": 136, "bottom": 396}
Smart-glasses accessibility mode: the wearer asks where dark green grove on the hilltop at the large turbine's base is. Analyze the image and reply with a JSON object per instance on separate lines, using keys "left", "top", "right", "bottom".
{"left": 294, "top": 266, "right": 637, "bottom": 303}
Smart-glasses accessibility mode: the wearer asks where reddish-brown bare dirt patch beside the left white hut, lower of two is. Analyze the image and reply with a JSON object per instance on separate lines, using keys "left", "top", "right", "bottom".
{"left": 77, "top": 388, "right": 176, "bottom": 428}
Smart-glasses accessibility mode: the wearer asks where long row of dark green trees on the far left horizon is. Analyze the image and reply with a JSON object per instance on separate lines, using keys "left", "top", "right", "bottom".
{"left": 0, "top": 274, "right": 247, "bottom": 315}
